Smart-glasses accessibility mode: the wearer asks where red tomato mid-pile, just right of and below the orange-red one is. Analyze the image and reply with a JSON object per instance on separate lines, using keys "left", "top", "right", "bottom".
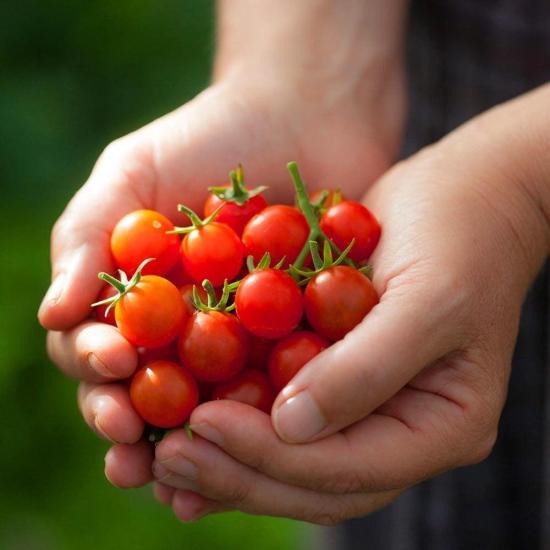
{"left": 178, "top": 311, "right": 248, "bottom": 382}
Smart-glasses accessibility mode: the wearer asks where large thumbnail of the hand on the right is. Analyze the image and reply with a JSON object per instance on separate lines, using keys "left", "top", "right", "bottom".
{"left": 273, "top": 391, "right": 327, "bottom": 443}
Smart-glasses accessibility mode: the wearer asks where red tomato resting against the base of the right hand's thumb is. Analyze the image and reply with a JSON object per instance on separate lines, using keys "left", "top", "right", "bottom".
{"left": 304, "top": 265, "right": 378, "bottom": 341}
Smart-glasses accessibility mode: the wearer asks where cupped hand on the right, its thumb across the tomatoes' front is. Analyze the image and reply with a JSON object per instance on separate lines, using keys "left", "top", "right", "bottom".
{"left": 148, "top": 91, "right": 548, "bottom": 524}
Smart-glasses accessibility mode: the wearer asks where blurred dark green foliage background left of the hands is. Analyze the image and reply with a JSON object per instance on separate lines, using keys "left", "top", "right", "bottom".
{"left": 0, "top": 0, "right": 309, "bottom": 550}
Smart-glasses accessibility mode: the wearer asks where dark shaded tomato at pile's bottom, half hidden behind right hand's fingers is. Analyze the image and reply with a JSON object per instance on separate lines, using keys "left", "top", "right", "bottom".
{"left": 212, "top": 369, "right": 275, "bottom": 414}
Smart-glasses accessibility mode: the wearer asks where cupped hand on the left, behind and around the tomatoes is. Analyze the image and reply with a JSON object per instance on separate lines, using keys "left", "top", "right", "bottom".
{"left": 38, "top": 79, "right": 398, "bottom": 487}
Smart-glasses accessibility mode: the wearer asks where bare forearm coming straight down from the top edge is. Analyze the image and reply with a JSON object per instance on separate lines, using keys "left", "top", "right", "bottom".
{"left": 214, "top": 0, "right": 408, "bottom": 155}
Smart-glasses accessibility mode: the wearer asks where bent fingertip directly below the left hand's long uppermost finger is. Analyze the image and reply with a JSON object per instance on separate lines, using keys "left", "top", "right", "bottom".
{"left": 47, "top": 322, "right": 138, "bottom": 382}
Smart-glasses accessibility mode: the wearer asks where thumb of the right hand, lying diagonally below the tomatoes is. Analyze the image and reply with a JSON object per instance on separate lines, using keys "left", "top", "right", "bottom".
{"left": 272, "top": 276, "right": 462, "bottom": 443}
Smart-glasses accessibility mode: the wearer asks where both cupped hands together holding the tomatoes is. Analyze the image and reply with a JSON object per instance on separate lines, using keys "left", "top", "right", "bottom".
{"left": 39, "top": 83, "right": 541, "bottom": 524}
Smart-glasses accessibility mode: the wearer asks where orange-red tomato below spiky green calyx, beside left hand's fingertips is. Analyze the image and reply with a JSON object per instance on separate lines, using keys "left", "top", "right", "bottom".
{"left": 115, "top": 275, "right": 188, "bottom": 348}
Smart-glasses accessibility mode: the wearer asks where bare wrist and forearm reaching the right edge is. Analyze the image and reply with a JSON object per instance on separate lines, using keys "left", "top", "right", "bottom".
{"left": 436, "top": 86, "right": 550, "bottom": 285}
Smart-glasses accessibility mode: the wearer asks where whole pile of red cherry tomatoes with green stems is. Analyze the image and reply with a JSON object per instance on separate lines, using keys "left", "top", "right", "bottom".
{"left": 94, "top": 163, "right": 380, "bottom": 436}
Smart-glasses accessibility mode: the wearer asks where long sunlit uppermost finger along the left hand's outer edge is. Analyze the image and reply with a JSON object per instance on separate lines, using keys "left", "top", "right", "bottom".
{"left": 38, "top": 139, "right": 154, "bottom": 330}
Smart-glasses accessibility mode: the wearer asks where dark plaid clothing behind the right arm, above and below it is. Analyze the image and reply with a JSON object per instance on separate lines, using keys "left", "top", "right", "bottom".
{"left": 338, "top": 0, "right": 550, "bottom": 550}
